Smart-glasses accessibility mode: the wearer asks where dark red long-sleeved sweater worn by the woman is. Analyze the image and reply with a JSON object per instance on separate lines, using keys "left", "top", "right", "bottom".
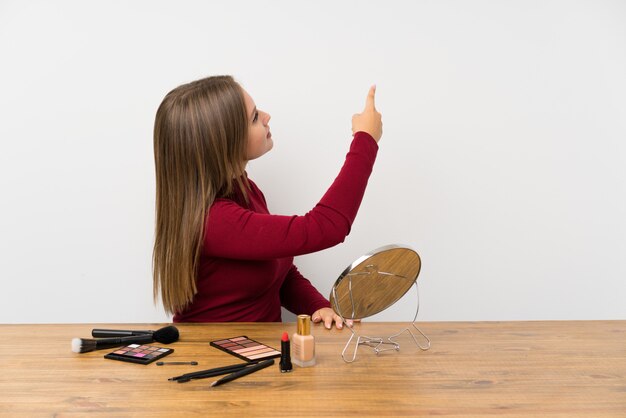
{"left": 174, "top": 132, "right": 378, "bottom": 322}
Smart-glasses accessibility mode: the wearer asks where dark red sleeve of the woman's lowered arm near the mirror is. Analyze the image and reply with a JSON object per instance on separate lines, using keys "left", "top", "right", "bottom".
{"left": 280, "top": 265, "right": 330, "bottom": 315}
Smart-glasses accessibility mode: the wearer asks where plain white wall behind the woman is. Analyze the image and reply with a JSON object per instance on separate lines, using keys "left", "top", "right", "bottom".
{"left": 0, "top": 0, "right": 626, "bottom": 323}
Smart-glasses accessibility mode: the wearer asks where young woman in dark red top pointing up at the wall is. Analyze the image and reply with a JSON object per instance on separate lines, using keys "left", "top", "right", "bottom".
{"left": 153, "top": 76, "right": 382, "bottom": 328}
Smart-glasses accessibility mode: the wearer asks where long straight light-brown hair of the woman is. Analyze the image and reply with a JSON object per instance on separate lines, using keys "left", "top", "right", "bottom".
{"left": 152, "top": 76, "right": 248, "bottom": 314}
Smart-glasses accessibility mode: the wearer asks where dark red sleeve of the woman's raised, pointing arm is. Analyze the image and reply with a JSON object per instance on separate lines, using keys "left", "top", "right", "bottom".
{"left": 203, "top": 132, "right": 378, "bottom": 260}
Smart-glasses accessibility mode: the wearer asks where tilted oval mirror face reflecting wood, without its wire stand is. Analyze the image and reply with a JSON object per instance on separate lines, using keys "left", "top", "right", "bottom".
{"left": 330, "top": 245, "right": 422, "bottom": 319}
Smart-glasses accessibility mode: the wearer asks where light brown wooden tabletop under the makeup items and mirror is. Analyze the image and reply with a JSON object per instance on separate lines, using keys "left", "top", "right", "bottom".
{"left": 0, "top": 321, "right": 626, "bottom": 418}
